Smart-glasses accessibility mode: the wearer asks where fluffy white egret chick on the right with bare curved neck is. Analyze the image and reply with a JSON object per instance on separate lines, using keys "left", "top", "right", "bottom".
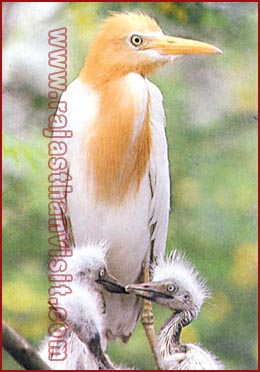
{"left": 126, "top": 251, "right": 223, "bottom": 370}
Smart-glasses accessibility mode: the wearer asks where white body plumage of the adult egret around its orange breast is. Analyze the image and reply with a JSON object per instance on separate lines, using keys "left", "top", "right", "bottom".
{"left": 61, "top": 74, "right": 170, "bottom": 338}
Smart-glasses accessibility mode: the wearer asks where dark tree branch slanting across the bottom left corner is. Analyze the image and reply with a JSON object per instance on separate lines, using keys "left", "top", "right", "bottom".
{"left": 2, "top": 320, "right": 51, "bottom": 370}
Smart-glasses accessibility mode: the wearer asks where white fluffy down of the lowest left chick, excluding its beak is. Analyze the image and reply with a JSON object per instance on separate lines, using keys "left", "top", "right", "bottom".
{"left": 39, "top": 285, "right": 106, "bottom": 371}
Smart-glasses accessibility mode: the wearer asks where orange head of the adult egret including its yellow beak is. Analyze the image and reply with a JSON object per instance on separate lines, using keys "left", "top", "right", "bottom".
{"left": 81, "top": 12, "right": 221, "bottom": 85}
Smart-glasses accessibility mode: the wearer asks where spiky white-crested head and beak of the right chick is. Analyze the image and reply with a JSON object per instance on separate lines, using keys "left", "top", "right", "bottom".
{"left": 126, "top": 250, "right": 210, "bottom": 314}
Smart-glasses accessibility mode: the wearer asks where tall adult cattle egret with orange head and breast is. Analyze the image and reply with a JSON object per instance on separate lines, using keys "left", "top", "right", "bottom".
{"left": 57, "top": 13, "right": 220, "bottom": 356}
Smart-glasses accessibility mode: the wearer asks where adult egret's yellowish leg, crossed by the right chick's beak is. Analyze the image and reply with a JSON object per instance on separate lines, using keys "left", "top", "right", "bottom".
{"left": 141, "top": 264, "right": 160, "bottom": 369}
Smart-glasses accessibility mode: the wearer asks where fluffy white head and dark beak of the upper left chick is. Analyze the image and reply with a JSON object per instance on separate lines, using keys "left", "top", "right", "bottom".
{"left": 67, "top": 242, "right": 125, "bottom": 293}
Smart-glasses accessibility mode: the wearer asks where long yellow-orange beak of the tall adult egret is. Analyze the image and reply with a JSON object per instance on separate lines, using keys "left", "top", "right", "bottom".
{"left": 146, "top": 35, "right": 223, "bottom": 56}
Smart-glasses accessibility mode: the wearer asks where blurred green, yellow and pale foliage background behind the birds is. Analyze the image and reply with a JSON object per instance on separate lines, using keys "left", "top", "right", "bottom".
{"left": 3, "top": 2, "right": 258, "bottom": 370}
